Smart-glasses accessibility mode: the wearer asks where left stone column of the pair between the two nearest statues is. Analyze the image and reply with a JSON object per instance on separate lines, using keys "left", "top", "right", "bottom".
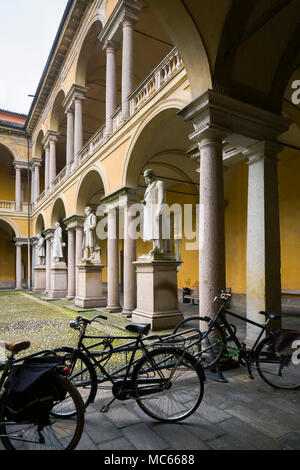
{"left": 106, "top": 209, "right": 122, "bottom": 312}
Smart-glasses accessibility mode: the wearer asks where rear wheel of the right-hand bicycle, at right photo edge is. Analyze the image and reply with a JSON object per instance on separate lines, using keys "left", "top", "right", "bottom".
{"left": 255, "top": 338, "right": 300, "bottom": 390}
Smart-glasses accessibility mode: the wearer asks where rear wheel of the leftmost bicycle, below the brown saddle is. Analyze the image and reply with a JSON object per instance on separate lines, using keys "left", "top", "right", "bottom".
{"left": 0, "top": 375, "right": 85, "bottom": 451}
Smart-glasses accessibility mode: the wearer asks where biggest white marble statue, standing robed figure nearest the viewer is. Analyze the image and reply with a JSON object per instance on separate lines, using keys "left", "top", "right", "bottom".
{"left": 142, "top": 169, "right": 166, "bottom": 253}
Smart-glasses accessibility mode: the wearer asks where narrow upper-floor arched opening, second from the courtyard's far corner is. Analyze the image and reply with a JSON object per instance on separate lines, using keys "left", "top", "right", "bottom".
{"left": 50, "top": 90, "right": 67, "bottom": 175}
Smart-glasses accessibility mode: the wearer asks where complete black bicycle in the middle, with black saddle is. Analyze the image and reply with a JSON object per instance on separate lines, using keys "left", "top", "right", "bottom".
{"left": 55, "top": 315, "right": 205, "bottom": 422}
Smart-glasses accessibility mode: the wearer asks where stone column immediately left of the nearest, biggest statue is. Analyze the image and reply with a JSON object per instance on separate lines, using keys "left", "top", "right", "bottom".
{"left": 123, "top": 207, "right": 136, "bottom": 315}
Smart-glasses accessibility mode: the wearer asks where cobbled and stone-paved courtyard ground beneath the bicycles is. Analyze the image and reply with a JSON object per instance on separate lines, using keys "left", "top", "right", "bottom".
{"left": 0, "top": 294, "right": 300, "bottom": 451}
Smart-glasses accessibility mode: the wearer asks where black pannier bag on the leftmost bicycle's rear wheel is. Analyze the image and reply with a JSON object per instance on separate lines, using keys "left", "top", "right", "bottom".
{"left": 5, "top": 356, "right": 66, "bottom": 429}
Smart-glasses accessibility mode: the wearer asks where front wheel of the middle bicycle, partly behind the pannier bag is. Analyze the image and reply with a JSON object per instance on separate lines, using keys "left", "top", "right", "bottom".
{"left": 54, "top": 347, "right": 98, "bottom": 416}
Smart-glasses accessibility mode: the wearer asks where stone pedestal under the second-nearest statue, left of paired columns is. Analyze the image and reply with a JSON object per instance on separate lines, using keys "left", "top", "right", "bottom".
{"left": 75, "top": 262, "right": 106, "bottom": 308}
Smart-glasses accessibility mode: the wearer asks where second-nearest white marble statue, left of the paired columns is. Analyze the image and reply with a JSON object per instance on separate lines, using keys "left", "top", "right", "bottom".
{"left": 82, "top": 207, "right": 100, "bottom": 262}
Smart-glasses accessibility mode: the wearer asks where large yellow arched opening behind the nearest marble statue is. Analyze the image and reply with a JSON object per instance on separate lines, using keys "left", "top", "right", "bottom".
{"left": 125, "top": 108, "right": 199, "bottom": 289}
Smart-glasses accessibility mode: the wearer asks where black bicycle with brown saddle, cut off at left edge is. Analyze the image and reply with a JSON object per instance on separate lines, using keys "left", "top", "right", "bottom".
{"left": 0, "top": 341, "right": 85, "bottom": 451}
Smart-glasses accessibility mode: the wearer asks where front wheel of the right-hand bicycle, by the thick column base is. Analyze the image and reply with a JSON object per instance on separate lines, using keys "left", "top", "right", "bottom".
{"left": 173, "top": 315, "right": 226, "bottom": 369}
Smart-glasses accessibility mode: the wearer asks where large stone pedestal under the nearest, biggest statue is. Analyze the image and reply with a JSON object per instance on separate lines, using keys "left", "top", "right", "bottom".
{"left": 132, "top": 256, "right": 183, "bottom": 330}
